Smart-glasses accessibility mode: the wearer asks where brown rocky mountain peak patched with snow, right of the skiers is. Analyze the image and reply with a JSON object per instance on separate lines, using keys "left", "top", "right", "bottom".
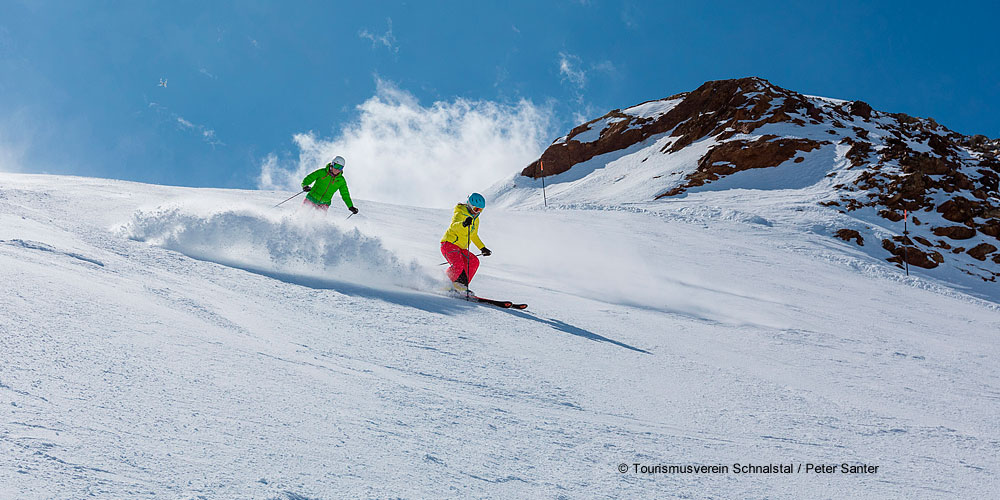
{"left": 520, "top": 77, "right": 1000, "bottom": 281}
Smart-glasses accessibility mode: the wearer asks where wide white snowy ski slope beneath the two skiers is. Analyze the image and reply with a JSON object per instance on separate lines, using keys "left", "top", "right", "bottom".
{"left": 0, "top": 173, "right": 1000, "bottom": 499}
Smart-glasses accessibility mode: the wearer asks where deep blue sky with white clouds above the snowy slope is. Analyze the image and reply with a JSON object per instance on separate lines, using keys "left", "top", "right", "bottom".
{"left": 0, "top": 0, "right": 1000, "bottom": 203}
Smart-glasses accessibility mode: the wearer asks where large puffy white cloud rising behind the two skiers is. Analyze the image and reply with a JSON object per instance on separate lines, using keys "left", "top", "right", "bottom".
{"left": 258, "top": 80, "right": 552, "bottom": 207}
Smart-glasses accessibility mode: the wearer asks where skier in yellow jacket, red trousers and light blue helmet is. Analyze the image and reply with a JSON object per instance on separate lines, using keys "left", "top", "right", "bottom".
{"left": 441, "top": 193, "right": 493, "bottom": 293}
